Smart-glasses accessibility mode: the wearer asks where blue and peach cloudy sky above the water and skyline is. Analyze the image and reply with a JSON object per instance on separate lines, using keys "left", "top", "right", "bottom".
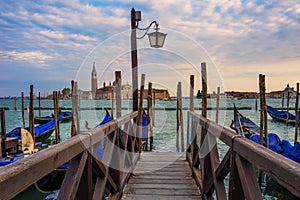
{"left": 0, "top": 0, "right": 300, "bottom": 96}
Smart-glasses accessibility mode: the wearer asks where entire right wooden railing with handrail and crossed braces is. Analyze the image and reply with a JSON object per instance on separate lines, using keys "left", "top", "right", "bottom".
{"left": 186, "top": 111, "right": 300, "bottom": 200}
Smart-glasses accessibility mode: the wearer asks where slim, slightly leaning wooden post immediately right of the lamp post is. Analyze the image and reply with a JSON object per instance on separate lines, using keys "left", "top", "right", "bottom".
{"left": 137, "top": 74, "right": 145, "bottom": 153}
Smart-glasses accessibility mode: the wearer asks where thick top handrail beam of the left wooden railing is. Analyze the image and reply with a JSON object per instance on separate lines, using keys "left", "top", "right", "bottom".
{"left": 0, "top": 111, "right": 138, "bottom": 199}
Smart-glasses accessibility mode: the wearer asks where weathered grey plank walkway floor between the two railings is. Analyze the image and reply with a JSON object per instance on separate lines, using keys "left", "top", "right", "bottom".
{"left": 122, "top": 152, "right": 200, "bottom": 200}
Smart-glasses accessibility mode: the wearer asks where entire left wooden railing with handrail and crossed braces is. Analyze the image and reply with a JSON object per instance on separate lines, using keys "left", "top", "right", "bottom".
{"left": 0, "top": 112, "right": 139, "bottom": 200}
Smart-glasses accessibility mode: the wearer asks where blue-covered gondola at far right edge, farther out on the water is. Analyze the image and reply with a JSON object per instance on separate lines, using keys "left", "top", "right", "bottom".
{"left": 267, "top": 106, "right": 300, "bottom": 125}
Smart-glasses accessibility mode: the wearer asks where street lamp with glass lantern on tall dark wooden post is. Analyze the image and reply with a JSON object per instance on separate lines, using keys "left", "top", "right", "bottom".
{"left": 131, "top": 8, "right": 167, "bottom": 111}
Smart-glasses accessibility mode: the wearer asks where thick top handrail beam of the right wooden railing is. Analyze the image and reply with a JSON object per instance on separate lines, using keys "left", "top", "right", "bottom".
{"left": 188, "top": 111, "right": 300, "bottom": 197}
